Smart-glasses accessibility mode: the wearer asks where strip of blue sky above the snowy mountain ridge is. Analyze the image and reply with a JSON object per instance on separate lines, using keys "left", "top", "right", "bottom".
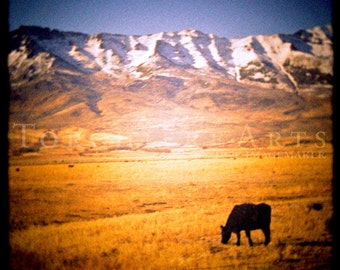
{"left": 9, "top": 0, "right": 332, "bottom": 38}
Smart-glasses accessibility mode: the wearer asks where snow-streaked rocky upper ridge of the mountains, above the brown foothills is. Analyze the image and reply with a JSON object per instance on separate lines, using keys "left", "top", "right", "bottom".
{"left": 8, "top": 25, "right": 333, "bottom": 91}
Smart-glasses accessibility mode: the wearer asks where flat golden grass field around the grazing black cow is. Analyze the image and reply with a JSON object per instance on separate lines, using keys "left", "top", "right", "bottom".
{"left": 9, "top": 149, "right": 333, "bottom": 270}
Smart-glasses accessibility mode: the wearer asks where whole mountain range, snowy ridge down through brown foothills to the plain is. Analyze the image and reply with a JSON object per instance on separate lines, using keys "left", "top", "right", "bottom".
{"left": 8, "top": 25, "right": 333, "bottom": 156}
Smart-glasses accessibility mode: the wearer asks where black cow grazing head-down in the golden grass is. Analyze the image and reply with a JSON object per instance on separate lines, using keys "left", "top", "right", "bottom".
{"left": 221, "top": 203, "right": 271, "bottom": 246}
